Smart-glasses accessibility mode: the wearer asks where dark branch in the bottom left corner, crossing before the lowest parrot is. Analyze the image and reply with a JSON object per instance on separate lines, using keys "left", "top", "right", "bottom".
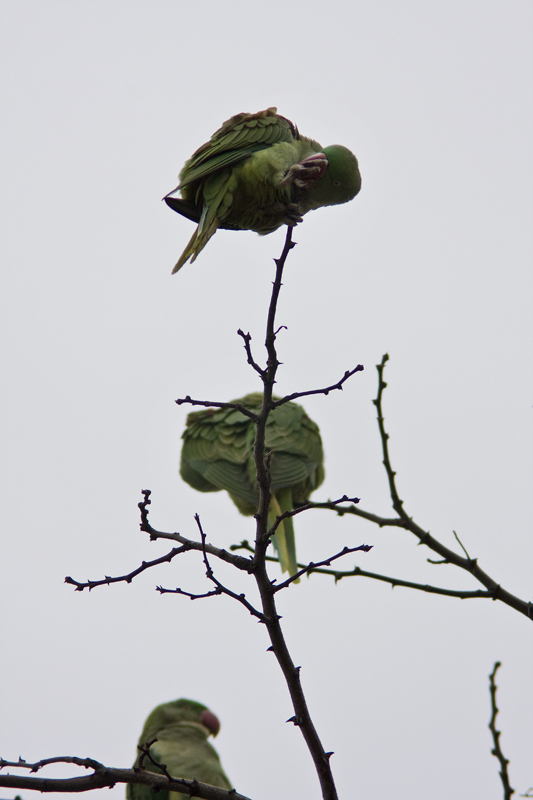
{"left": 0, "top": 756, "right": 249, "bottom": 800}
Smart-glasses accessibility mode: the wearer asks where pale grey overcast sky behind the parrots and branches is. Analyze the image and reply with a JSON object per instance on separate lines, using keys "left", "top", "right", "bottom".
{"left": 0, "top": 0, "right": 533, "bottom": 800}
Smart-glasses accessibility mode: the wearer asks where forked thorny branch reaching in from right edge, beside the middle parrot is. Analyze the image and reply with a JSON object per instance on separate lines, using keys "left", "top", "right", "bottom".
{"left": 316, "top": 354, "right": 533, "bottom": 620}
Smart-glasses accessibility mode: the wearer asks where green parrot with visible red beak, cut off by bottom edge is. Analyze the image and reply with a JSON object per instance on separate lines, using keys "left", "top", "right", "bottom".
{"left": 126, "top": 698, "right": 232, "bottom": 800}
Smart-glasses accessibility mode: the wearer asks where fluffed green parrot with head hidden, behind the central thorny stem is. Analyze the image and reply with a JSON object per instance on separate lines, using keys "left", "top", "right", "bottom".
{"left": 180, "top": 392, "right": 325, "bottom": 576}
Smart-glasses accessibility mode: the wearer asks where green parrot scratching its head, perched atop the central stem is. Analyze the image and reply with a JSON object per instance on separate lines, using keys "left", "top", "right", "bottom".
{"left": 164, "top": 108, "right": 361, "bottom": 272}
